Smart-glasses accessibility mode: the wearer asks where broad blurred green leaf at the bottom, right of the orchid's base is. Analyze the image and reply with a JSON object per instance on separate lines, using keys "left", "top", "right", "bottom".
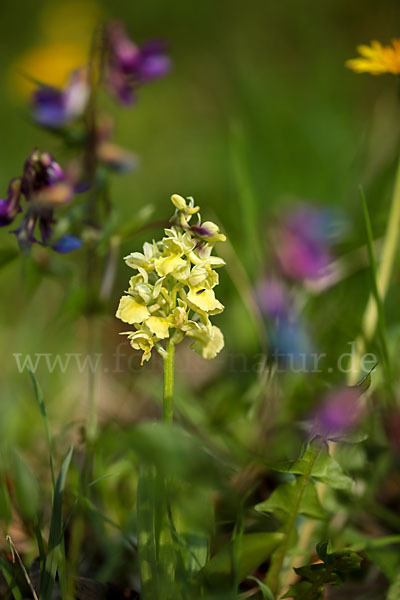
{"left": 200, "top": 533, "right": 284, "bottom": 588}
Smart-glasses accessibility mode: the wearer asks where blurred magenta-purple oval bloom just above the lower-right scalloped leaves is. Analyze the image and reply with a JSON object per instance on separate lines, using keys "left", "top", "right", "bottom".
{"left": 312, "top": 387, "right": 363, "bottom": 439}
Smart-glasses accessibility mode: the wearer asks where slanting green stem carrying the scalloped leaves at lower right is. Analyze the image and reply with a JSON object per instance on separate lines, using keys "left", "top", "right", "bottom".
{"left": 266, "top": 443, "right": 322, "bottom": 594}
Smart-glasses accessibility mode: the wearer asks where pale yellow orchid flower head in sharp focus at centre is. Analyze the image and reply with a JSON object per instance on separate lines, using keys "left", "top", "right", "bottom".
{"left": 117, "top": 194, "right": 225, "bottom": 364}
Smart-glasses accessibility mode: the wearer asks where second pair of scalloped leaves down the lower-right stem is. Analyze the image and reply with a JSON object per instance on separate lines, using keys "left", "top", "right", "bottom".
{"left": 255, "top": 479, "right": 326, "bottom": 519}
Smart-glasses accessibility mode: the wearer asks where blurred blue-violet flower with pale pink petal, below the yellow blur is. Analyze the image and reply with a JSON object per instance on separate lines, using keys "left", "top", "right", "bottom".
{"left": 32, "top": 68, "right": 90, "bottom": 129}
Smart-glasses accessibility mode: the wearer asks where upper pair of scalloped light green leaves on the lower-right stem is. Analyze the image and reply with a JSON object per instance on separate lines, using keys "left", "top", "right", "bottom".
{"left": 270, "top": 442, "right": 353, "bottom": 491}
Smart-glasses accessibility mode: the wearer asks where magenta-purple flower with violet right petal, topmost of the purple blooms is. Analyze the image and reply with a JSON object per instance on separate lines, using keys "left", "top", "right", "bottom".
{"left": 106, "top": 22, "right": 171, "bottom": 105}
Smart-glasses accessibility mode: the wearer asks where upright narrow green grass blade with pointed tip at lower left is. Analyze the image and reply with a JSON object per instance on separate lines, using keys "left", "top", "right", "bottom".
{"left": 40, "top": 446, "right": 73, "bottom": 600}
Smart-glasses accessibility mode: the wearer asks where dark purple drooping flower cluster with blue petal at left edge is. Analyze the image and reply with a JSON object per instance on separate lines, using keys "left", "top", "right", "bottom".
{"left": 0, "top": 149, "right": 78, "bottom": 253}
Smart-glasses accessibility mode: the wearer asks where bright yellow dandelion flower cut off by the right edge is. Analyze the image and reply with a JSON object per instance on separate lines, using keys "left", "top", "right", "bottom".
{"left": 346, "top": 39, "right": 400, "bottom": 75}
